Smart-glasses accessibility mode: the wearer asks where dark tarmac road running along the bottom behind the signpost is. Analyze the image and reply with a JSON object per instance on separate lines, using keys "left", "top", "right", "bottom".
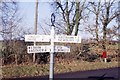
{"left": 2, "top": 67, "right": 120, "bottom": 80}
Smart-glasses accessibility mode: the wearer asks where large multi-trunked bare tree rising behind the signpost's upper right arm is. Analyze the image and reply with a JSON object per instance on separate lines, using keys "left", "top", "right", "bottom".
{"left": 52, "top": 0, "right": 86, "bottom": 35}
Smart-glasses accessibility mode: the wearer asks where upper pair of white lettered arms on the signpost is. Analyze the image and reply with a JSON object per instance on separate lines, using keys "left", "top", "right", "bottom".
{"left": 25, "top": 35, "right": 81, "bottom": 43}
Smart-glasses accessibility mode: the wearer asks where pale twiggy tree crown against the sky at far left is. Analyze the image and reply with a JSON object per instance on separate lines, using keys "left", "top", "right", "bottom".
{"left": 1, "top": 2, "right": 22, "bottom": 40}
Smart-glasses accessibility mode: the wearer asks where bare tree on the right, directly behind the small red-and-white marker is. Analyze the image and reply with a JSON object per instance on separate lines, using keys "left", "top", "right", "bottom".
{"left": 100, "top": 0, "right": 120, "bottom": 51}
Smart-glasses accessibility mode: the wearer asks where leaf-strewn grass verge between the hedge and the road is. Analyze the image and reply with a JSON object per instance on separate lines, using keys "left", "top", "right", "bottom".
{"left": 2, "top": 60, "right": 118, "bottom": 78}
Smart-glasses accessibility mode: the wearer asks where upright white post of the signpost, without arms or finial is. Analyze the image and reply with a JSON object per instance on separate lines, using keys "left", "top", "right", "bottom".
{"left": 49, "top": 26, "right": 55, "bottom": 80}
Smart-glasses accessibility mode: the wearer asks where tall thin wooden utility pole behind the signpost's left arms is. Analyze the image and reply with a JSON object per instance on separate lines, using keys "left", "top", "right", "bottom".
{"left": 33, "top": 0, "right": 38, "bottom": 63}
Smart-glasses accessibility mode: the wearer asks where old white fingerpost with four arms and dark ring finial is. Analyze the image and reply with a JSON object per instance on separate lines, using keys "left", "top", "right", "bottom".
{"left": 25, "top": 14, "right": 81, "bottom": 80}
